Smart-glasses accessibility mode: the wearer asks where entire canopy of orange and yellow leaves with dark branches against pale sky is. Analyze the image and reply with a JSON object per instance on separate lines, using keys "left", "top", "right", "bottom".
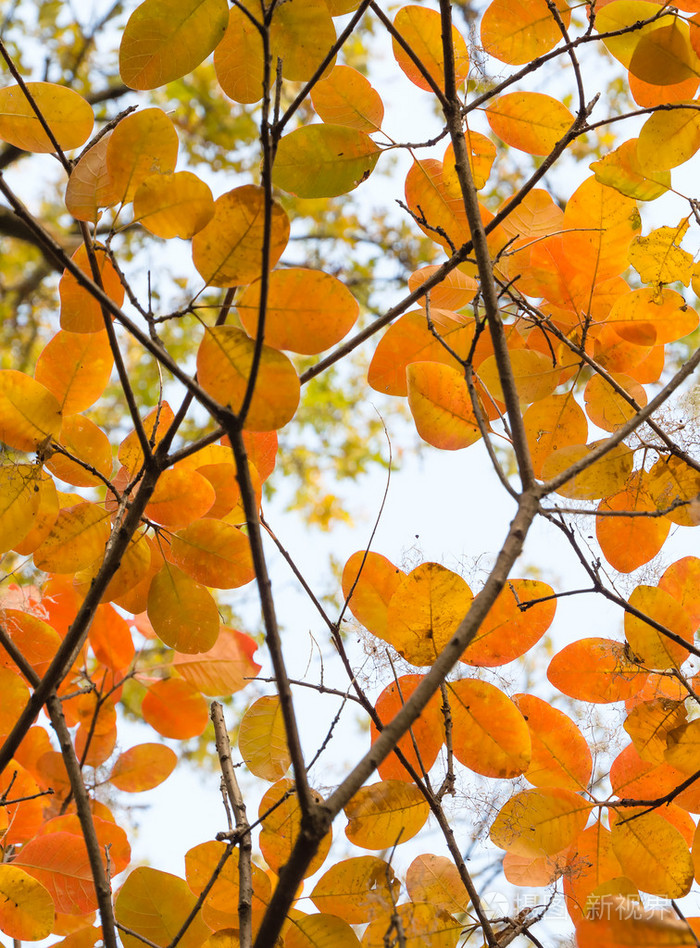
{"left": 5, "top": 0, "right": 700, "bottom": 948}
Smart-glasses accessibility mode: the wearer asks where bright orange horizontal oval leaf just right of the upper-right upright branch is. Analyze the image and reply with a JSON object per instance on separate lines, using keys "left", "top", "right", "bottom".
{"left": 486, "top": 92, "right": 574, "bottom": 155}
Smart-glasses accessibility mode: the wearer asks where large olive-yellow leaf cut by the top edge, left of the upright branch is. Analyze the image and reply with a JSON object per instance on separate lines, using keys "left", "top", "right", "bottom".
{"left": 119, "top": 0, "right": 228, "bottom": 89}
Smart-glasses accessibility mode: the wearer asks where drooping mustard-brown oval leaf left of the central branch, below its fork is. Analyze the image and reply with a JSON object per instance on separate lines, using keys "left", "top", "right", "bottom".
{"left": 148, "top": 563, "right": 219, "bottom": 654}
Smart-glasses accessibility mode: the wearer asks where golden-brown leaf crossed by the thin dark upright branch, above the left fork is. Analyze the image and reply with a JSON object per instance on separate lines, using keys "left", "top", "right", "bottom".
{"left": 197, "top": 326, "right": 299, "bottom": 431}
